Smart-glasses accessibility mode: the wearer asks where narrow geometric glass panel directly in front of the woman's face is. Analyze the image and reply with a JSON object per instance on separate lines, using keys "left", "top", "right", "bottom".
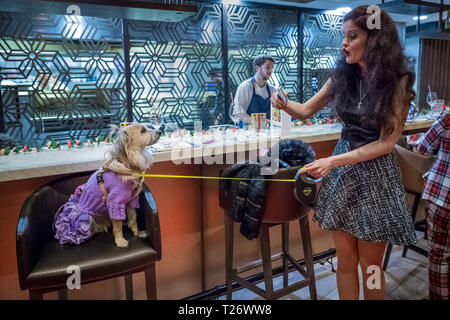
{"left": 302, "top": 13, "right": 343, "bottom": 114}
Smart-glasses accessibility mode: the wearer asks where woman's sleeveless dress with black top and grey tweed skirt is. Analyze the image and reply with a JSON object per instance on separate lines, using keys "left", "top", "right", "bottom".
{"left": 313, "top": 82, "right": 416, "bottom": 245}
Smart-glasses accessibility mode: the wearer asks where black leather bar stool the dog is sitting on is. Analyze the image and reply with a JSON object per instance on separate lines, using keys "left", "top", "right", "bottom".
{"left": 16, "top": 172, "right": 162, "bottom": 300}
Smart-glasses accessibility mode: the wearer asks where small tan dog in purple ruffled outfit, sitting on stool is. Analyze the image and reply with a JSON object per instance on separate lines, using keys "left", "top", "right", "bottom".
{"left": 54, "top": 124, "right": 161, "bottom": 248}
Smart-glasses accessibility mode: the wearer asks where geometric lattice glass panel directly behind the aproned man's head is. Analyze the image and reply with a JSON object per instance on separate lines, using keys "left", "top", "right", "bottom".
{"left": 227, "top": 5, "right": 299, "bottom": 110}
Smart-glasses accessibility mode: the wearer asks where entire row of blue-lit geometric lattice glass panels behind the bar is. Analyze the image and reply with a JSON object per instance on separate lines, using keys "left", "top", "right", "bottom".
{"left": 0, "top": 3, "right": 366, "bottom": 145}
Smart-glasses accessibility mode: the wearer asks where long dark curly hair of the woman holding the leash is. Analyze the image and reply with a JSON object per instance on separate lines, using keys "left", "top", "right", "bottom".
{"left": 330, "top": 6, "right": 415, "bottom": 135}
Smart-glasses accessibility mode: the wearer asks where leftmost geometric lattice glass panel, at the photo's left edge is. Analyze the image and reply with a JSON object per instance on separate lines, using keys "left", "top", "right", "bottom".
{"left": 0, "top": 12, "right": 126, "bottom": 145}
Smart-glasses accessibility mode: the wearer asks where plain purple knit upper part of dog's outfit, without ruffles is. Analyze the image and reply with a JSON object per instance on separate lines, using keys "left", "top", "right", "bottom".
{"left": 79, "top": 171, "right": 139, "bottom": 220}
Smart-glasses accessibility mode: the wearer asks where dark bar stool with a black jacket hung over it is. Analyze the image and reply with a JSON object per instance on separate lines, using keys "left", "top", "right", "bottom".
{"left": 219, "top": 167, "right": 317, "bottom": 300}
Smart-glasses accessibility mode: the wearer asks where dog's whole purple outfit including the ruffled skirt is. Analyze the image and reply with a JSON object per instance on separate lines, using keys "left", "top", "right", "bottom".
{"left": 54, "top": 171, "right": 139, "bottom": 244}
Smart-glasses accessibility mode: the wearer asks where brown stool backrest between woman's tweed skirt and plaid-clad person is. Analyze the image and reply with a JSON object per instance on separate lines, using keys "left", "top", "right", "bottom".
{"left": 395, "top": 145, "right": 436, "bottom": 193}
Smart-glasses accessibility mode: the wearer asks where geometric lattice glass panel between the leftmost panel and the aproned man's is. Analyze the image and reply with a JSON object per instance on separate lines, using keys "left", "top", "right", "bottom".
{"left": 128, "top": 4, "right": 224, "bottom": 129}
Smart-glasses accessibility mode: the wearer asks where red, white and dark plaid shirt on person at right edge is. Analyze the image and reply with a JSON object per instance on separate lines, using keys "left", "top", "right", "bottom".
{"left": 418, "top": 112, "right": 450, "bottom": 209}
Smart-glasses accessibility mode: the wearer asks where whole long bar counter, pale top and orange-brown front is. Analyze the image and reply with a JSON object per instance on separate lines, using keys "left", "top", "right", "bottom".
{"left": 0, "top": 121, "right": 432, "bottom": 299}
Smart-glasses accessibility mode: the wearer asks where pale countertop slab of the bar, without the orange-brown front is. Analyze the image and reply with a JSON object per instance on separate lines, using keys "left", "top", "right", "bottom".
{"left": 0, "top": 121, "right": 432, "bottom": 182}
